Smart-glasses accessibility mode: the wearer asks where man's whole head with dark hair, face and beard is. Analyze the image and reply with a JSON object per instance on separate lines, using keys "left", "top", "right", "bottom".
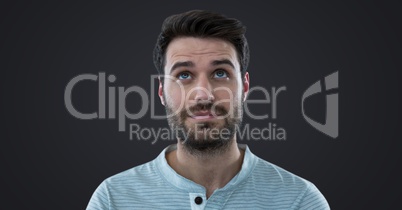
{"left": 154, "top": 11, "right": 249, "bottom": 155}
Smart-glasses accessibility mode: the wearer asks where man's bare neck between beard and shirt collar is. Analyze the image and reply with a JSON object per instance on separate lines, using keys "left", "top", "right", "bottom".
{"left": 166, "top": 139, "right": 244, "bottom": 197}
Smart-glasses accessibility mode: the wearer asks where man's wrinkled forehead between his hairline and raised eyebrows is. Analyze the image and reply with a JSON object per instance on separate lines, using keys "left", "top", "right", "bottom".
{"left": 165, "top": 37, "right": 239, "bottom": 73}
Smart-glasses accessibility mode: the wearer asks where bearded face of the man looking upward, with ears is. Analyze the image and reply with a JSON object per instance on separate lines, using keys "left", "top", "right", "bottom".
{"left": 159, "top": 37, "right": 249, "bottom": 156}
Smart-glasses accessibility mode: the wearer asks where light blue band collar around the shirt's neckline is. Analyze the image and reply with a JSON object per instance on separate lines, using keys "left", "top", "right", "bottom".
{"left": 156, "top": 144, "right": 257, "bottom": 193}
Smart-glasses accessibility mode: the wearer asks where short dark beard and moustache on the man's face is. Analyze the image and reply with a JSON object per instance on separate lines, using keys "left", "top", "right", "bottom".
{"left": 165, "top": 100, "right": 242, "bottom": 158}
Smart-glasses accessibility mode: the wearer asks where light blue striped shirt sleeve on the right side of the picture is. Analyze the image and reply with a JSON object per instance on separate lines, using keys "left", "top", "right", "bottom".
{"left": 298, "top": 183, "right": 330, "bottom": 210}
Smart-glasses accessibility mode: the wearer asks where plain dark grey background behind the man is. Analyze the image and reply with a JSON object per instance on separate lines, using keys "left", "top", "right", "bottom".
{"left": 0, "top": 1, "right": 402, "bottom": 209}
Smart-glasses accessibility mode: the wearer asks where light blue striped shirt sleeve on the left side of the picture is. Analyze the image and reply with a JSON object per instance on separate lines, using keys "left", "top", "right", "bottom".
{"left": 86, "top": 182, "right": 110, "bottom": 210}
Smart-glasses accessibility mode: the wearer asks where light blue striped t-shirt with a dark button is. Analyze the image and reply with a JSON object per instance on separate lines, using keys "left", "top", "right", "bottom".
{"left": 87, "top": 144, "right": 329, "bottom": 210}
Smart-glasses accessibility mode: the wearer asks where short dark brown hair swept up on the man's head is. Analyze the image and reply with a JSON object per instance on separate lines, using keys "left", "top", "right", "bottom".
{"left": 153, "top": 10, "right": 250, "bottom": 77}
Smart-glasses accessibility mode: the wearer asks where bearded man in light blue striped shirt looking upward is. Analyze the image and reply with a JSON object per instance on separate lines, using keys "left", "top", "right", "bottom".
{"left": 87, "top": 11, "right": 329, "bottom": 209}
